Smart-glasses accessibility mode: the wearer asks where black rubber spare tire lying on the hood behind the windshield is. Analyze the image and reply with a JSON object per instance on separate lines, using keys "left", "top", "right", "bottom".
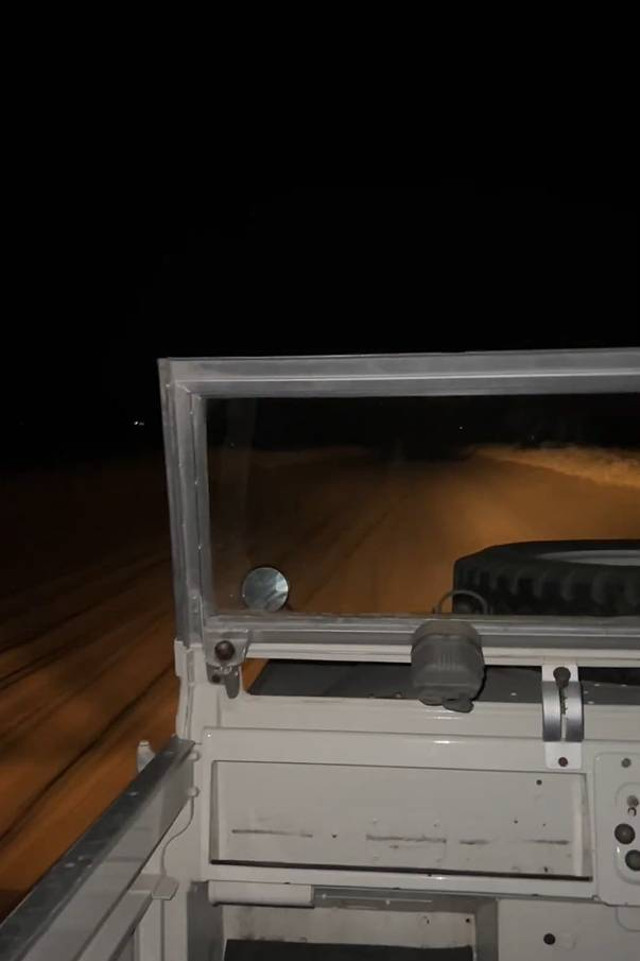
{"left": 453, "top": 540, "right": 640, "bottom": 617}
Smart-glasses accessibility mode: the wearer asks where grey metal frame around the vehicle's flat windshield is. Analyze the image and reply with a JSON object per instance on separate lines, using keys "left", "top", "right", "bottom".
{"left": 159, "top": 348, "right": 640, "bottom": 666}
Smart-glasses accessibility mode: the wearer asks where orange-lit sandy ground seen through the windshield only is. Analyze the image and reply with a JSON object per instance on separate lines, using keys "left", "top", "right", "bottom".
{"left": 212, "top": 448, "right": 640, "bottom": 614}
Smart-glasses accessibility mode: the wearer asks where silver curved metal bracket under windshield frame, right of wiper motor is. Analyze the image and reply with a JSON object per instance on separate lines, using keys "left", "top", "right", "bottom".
{"left": 542, "top": 664, "right": 584, "bottom": 770}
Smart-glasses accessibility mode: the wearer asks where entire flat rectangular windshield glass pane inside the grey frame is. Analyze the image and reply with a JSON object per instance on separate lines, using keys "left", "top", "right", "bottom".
{"left": 208, "top": 394, "right": 640, "bottom": 616}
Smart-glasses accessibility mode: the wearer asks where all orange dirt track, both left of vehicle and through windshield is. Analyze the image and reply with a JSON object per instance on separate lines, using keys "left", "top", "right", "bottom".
{"left": 0, "top": 446, "right": 640, "bottom": 909}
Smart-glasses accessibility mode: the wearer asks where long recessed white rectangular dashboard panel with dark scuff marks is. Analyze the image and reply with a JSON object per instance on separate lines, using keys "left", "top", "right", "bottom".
{"left": 217, "top": 763, "right": 588, "bottom": 876}
